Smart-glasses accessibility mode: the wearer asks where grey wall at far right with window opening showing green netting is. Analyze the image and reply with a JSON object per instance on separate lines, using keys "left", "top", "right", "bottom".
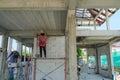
{"left": 97, "top": 45, "right": 112, "bottom": 78}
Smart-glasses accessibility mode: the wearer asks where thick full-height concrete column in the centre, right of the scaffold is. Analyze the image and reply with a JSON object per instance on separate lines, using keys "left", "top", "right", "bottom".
{"left": 66, "top": 10, "right": 78, "bottom": 80}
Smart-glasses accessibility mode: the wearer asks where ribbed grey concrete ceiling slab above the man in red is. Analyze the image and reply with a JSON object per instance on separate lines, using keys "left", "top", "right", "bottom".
{"left": 0, "top": 10, "right": 66, "bottom": 30}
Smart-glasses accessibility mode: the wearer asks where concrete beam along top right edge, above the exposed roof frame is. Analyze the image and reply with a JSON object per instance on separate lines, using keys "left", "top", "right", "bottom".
{"left": 77, "top": 0, "right": 120, "bottom": 8}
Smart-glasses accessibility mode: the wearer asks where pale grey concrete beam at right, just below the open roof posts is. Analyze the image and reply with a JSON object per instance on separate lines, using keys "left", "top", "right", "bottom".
{"left": 76, "top": 30, "right": 120, "bottom": 37}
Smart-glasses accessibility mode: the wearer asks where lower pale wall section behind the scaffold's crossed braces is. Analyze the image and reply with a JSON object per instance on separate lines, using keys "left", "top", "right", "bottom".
{"left": 35, "top": 59, "right": 65, "bottom": 80}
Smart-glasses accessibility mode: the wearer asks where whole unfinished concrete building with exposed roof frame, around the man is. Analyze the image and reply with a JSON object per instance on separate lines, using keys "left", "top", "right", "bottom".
{"left": 0, "top": 0, "right": 120, "bottom": 80}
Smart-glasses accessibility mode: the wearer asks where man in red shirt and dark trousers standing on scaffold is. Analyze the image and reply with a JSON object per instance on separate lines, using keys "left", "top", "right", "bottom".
{"left": 38, "top": 31, "right": 47, "bottom": 58}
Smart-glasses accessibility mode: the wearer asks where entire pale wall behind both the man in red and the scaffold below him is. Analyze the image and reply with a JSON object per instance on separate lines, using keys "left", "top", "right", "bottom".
{"left": 32, "top": 36, "right": 65, "bottom": 80}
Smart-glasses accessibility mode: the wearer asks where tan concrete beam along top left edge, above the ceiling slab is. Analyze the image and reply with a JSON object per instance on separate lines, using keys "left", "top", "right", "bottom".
{"left": 0, "top": 0, "right": 67, "bottom": 10}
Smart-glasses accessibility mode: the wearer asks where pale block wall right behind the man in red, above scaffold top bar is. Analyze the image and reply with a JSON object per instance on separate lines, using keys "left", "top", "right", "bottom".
{"left": 37, "top": 36, "right": 65, "bottom": 58}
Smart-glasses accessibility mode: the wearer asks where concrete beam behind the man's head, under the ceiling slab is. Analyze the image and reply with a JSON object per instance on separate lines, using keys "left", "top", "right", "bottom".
{"left": 9, "top": 30, "right": 64, "bottom": 37}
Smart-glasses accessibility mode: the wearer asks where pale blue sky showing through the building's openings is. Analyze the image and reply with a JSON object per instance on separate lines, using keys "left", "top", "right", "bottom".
{"left": 0, "top": 10, "right": 120, "bottom": 50}
